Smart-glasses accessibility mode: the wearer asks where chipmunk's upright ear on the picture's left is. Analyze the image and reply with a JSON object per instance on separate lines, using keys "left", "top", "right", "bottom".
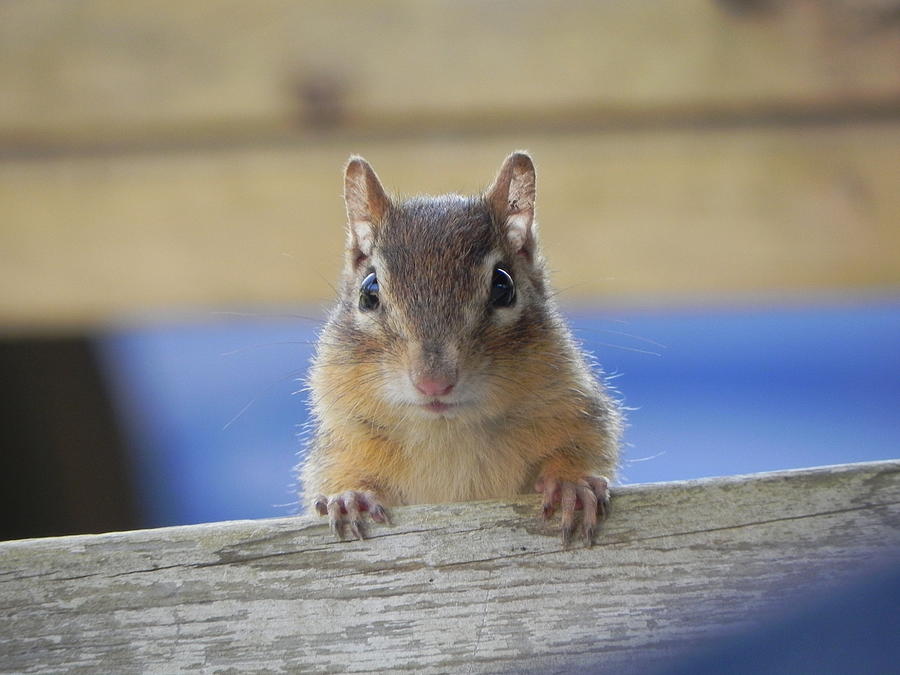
{"left": 344, "top": 155, "right": 391, "bottom": 263}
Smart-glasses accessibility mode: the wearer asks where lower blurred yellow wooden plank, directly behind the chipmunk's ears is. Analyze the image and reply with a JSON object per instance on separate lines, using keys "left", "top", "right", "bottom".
{"left": 0, "top": 124, "right": 900, "bottom": 327}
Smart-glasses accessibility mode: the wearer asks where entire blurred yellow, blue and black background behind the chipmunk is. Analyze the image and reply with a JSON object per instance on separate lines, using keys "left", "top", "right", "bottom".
{"left": 0, "top": 0, "right": 900, "bottom": 539}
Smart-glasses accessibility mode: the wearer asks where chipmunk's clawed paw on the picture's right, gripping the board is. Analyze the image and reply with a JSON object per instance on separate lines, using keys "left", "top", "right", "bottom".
{"left": 534, "top": 476, "right": 609, "bottom": 547}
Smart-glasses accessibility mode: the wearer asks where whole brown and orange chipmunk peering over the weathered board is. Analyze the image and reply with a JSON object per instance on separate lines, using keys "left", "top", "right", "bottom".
{"left": 301, "top": 152, "right": 622, "bottom": 545}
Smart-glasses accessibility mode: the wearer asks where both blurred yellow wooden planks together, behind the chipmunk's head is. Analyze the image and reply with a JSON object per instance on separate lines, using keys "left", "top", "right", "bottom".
{"left": 0, "top": 0, "right": 900, "bottom": 332}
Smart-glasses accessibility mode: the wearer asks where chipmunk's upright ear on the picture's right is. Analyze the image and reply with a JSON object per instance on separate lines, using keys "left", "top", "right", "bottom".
{"left": 485, "top": 151, "right": 534, "bottom": 258}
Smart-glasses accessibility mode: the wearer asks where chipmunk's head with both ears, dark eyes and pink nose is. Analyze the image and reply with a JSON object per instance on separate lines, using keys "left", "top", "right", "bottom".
{"left": 339, "top": 152, "right": 546, "bottom": 418}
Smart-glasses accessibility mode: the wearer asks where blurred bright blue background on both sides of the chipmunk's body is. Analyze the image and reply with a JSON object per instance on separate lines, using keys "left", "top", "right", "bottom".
{"left": 100, "top": 296, "right": 900, "bottom": 526}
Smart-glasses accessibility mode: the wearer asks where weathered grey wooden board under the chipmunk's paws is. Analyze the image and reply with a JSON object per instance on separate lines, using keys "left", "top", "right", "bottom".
{"left": 0, "top": 460, "right": 900, "bottom": 673}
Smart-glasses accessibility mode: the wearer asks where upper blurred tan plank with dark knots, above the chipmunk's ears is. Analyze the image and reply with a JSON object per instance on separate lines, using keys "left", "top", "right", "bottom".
{"left": 0, "top": 0, "right": 900, "bottom": 147}
